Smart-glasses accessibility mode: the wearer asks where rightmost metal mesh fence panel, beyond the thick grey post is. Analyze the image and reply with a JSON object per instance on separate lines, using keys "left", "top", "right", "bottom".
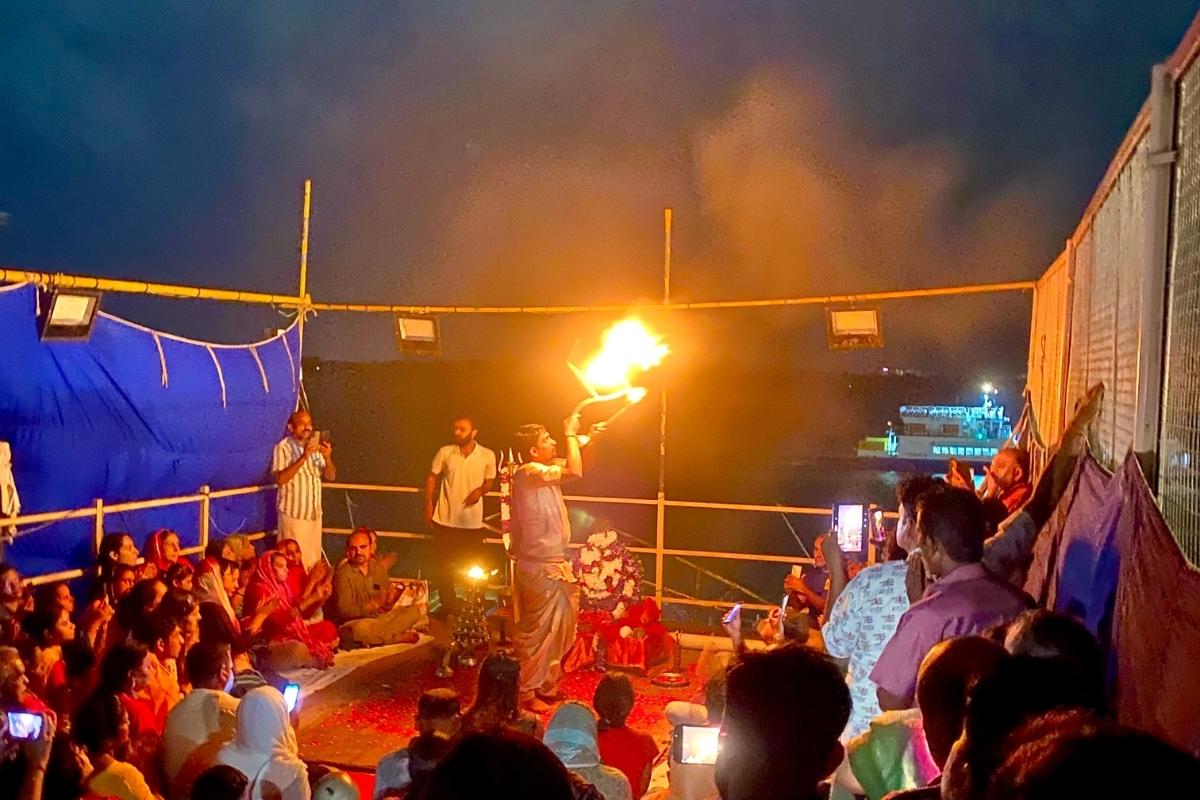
{"left": 1158, "top": 59, "right": 1200, "bottom": 565}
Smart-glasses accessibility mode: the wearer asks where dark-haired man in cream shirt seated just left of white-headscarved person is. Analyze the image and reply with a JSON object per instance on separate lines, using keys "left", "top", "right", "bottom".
{"left": 162, "top": 642, "right": 238, "bottom": 800}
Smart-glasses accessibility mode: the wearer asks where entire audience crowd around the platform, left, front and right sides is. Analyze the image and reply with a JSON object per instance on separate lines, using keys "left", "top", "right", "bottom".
{"left": 7, "top": 383, "right": 1200, "bottom": 800}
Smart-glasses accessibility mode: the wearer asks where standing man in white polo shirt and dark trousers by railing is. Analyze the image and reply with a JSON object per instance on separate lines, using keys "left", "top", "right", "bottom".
{"left": 425, "top": 416, "right": 496, "bottom": 616}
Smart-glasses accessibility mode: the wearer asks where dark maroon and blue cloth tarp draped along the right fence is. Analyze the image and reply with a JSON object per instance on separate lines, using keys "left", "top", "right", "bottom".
{"left": 1025, "top": 453, "right": 1200, "bottom": 754}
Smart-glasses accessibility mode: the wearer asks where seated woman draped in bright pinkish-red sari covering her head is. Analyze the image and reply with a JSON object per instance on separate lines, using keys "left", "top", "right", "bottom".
{"left": 242, "top": 551, "right": 337, "bottom": 664}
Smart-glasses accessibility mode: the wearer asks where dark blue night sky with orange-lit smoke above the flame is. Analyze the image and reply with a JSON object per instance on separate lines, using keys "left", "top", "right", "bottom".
{"left": 0, "top": 0, "right": 1196, "bottom": 369}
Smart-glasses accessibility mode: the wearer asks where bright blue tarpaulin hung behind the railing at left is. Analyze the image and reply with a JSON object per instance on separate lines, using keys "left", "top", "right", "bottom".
{"left": 0, "top": 284, "right": 300, "bottom": 575}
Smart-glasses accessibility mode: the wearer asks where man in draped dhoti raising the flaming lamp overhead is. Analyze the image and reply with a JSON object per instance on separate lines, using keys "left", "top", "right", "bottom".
{"left": 510, "top": 414, "right": 604, "bottom": 712}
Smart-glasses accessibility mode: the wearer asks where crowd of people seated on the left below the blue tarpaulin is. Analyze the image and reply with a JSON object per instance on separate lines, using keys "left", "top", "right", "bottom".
{"left": 0, "top": 529, "right": 420, "bottom": 800}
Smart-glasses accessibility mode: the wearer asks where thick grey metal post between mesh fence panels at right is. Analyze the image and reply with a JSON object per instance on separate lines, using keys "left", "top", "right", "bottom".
{"left": 1133, "top": 64, "right": 1175, "bottom": 489}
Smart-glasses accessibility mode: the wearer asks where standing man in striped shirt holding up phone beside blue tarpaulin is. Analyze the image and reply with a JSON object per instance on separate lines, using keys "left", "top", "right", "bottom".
{"left": 271, "top": 411, "right": 337, "bottom": 570}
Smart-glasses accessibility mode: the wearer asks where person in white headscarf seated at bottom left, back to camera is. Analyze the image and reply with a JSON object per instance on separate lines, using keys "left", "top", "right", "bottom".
{"left": 217, "top": 686, "right": 312, "bottom": 800}
